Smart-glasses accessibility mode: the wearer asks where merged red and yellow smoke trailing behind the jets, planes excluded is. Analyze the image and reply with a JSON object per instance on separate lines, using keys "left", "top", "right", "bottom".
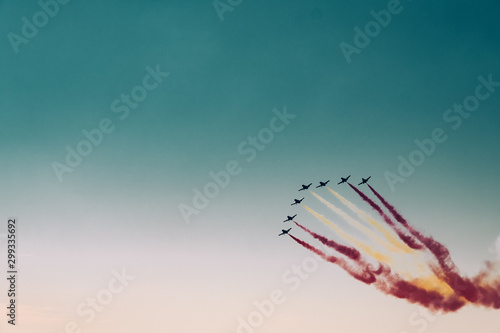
{"left": 290, "top": 184, "right": 500, "bottom": 312}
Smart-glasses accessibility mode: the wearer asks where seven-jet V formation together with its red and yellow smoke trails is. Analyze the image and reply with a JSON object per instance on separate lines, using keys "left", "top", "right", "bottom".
{"left": 280, "top": 175, "right": 500, "bottom": 312}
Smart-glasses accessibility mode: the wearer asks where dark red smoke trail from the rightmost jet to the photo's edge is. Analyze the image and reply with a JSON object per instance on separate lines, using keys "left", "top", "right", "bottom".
{"left": 368, "top": 184, "right": 500, "bottom": 309}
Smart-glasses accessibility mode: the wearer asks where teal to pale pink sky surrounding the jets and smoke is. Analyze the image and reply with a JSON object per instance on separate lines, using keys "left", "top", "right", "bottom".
{"left": 0, "top": 0, "right": 500, "bottom": 333}
